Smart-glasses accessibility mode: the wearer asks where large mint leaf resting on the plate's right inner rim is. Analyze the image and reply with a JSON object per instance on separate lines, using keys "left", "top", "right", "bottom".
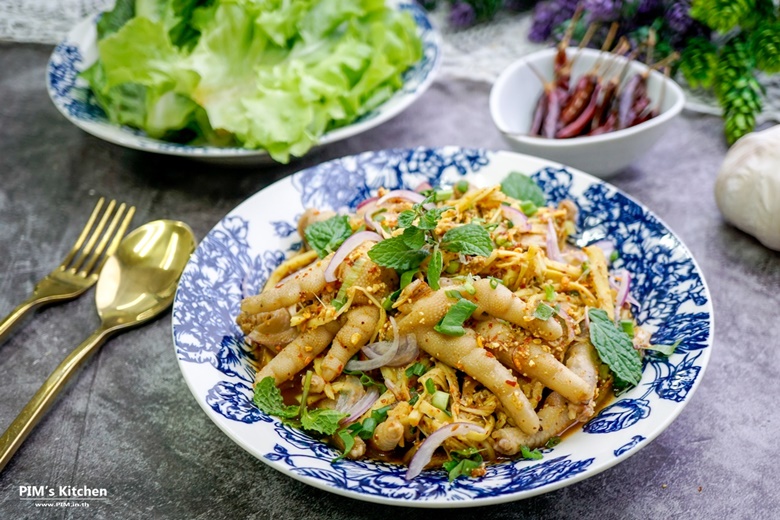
{"left": 588, "top": 309, "right": 642, "bottom": 385}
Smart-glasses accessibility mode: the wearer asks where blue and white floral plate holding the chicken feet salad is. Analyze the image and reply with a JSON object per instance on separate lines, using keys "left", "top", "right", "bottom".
{"left": 173, "top": 147, "right": 713, "bottom": 507}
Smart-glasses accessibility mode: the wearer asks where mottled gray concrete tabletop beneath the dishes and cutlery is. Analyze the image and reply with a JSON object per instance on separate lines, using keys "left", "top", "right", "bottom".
{"left": 0, "top": 44, "right": 780, "bottom": 520}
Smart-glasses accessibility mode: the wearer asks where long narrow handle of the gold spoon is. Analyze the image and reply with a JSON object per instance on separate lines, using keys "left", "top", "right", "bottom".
{"left": 0, "top": 327, "right": 109, "bottom": 471}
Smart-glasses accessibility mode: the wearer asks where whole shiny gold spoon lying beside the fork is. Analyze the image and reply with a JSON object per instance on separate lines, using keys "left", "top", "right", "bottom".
{"left": 0, "top": 220, "right": 195, "bottom": 471}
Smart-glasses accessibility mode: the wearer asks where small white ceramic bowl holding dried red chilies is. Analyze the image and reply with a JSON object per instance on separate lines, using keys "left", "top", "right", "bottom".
{"left": 490, "top": 48, "right": 685, "bottom": 178}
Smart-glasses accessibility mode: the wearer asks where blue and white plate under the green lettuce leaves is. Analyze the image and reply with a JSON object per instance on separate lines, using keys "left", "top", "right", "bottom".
{"left": 46, "top": 0, "right": 441, "bottom": 164}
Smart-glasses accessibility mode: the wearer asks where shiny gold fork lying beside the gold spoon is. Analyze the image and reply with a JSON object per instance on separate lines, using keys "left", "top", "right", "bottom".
{"left": 0, "top": 197, "right": 135, "bottom": 342}
